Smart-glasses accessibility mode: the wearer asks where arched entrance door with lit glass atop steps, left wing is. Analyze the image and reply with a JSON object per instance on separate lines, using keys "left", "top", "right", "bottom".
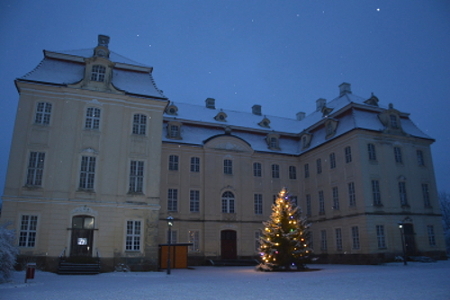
{"left": 70, "top": 216, "right": 94, "bottom": 256}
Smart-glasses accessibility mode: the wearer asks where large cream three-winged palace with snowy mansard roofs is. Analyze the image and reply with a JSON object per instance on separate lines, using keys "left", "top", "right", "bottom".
{"left": 1, "top": 35, "right": 445, "bottom": 271}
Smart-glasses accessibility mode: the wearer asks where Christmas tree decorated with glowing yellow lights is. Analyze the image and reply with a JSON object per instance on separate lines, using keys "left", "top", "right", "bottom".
{"left": 257, "top": 188, "right": 311, "bottom": 271}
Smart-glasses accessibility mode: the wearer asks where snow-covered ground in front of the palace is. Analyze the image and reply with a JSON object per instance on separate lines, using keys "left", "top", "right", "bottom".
{"left": 0, "top": 261, "right": 450, "bottom": 300}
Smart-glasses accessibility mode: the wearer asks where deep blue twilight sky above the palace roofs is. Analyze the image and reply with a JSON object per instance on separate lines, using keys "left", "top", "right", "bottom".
{"left": 0, "top": 0, "right": 450, "bottom": 197}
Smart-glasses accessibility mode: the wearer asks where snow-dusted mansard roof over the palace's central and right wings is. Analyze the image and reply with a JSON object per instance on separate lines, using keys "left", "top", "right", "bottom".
{"left": 162, "top": 85, "right": 431, "bottom": 155}
